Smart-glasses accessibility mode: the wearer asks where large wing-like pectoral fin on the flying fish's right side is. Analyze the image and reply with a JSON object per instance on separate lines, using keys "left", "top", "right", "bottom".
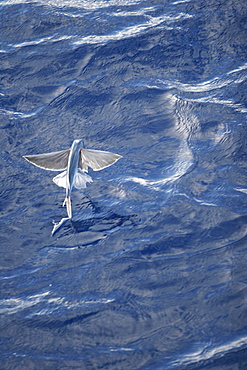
{"left": 79, "top": 149, "right": 122, "bottom": 171}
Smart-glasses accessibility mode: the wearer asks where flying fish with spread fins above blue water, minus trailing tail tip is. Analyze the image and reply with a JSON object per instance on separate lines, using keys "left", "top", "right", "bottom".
{"left": 24, "top": 140, "right": 121, "bottom": 218}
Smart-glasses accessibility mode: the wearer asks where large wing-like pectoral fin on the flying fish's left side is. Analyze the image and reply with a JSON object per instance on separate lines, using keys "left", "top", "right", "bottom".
{"left": 24, "top": 149, "right": 70, "bottom": 171}
